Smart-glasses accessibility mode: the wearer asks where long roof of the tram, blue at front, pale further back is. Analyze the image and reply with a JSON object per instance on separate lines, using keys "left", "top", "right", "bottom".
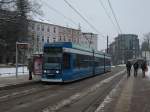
{"left": 44, "top": 42, "right": 109, "bottom": 56}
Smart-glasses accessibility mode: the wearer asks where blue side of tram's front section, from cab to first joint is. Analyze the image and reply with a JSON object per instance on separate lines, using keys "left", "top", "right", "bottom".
{"left": 63, "top": 53, "right": 93, "bottom": 81}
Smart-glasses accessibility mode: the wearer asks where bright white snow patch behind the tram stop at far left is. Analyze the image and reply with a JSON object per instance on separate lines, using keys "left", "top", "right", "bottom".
{"left": 0, "top": 67, "right": 28, "bottom": 77}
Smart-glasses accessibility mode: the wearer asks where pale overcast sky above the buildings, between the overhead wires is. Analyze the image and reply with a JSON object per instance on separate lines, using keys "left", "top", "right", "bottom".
{"left": 37, "top": 0, "right": 150, "bottom": 50}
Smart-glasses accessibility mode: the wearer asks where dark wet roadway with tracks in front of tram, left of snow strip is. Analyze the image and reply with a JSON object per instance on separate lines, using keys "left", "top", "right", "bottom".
{"left": 0, "top": 69, "right": 125, "bottom": 112}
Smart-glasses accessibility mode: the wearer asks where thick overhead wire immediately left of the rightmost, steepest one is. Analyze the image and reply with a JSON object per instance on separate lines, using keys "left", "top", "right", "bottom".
{"left": 98, "top": 0, "right": 119, "bottom": 33}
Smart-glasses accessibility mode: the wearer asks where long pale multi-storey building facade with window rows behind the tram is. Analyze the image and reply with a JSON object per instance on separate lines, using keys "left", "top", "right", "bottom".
{"left": 29, "top": 21, "right": 98, "bottom": 53}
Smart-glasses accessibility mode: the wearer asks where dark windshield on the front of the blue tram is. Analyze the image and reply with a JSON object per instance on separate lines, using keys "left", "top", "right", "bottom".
{"left": 43, "top": 48, "right": 62, "bottom": 69}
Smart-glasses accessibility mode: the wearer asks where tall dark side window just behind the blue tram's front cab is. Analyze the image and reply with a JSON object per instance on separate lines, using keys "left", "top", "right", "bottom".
{"left": 63, "top": 53, "right": 70, "bottom": 69}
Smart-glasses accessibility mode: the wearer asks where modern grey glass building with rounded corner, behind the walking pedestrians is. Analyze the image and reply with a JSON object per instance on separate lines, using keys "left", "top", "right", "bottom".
{"left": 109, "top": 34, "right": 140, "bottom": 64}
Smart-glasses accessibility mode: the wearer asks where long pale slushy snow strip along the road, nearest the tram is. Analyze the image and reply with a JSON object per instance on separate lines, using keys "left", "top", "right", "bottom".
{"left": 42, "top": 70, "right": 125, "bottom": 112}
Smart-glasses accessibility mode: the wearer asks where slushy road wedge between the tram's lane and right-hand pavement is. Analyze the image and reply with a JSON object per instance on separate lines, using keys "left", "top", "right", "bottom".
{"left": 43, "top": 71, "right": 124, "bottom": 112}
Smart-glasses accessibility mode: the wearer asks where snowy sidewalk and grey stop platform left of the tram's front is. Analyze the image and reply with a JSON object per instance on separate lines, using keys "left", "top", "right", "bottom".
{"left": 0, "top": 67, "right": 40, "bottom": 89}
